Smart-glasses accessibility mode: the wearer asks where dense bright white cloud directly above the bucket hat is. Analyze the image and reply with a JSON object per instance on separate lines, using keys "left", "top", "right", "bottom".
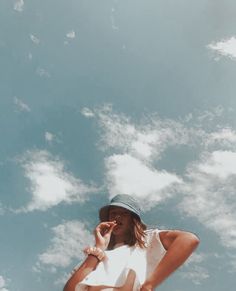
{"left": 106, "top": 154, "right": 181, "bottom": 208}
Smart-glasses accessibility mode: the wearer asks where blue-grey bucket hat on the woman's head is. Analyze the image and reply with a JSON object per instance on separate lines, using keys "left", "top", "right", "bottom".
{"left": 99, "top": 194, "right": 141, "bottom": 221}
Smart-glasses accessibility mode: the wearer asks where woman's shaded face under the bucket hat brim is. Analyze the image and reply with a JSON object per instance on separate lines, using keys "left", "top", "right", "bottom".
{"left": 108, "top": 206, "right": 133, "bottom": 235}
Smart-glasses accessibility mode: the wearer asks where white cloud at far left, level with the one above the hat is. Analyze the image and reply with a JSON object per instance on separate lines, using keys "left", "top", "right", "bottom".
{"left": 17, "top": 150, "right": 96, "bottom": 211}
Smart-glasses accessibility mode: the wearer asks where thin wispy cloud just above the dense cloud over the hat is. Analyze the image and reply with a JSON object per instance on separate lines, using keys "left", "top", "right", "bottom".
{"left": 95, "top": 106, "right": 191, "bottom": 161}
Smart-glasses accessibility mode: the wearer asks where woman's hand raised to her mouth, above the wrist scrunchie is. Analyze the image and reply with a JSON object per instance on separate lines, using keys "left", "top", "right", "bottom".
{"left": 94, "top": 221, "right": 117, "bottom": 251}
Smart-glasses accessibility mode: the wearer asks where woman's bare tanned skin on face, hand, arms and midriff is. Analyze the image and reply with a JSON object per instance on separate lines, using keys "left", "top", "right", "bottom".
{"left": 63, "top": 206, "right": 199, "bottom": 291}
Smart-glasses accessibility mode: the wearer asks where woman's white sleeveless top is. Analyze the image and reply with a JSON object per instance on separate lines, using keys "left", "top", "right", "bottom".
{"left": 75, "top": 229, "right": 166, "bottom": 291}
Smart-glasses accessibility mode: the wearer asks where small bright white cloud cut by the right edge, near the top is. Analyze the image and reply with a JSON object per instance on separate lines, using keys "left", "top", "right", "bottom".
{"left": 207, "top": 36, "right": 236, "bottom": 59}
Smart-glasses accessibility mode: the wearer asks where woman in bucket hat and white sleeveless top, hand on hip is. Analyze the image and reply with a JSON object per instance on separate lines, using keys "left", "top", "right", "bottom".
{"left": 64, "top": 194, "right": 199, "bottom": 291}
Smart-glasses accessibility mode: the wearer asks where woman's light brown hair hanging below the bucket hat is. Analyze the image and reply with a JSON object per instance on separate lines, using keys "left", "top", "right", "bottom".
{"left": 108, "top": 213, "right": 147, "bottom": 250}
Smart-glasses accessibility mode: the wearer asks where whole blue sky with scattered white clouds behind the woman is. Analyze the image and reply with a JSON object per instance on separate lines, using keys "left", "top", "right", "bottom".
{"left": 0, "top": 0, "right": 236, "bottom": 291}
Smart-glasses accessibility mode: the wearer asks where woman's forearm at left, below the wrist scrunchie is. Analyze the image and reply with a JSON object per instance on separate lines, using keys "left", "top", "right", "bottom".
{"left": 63, "top": 256, "right": 99, "bottom": 291}
